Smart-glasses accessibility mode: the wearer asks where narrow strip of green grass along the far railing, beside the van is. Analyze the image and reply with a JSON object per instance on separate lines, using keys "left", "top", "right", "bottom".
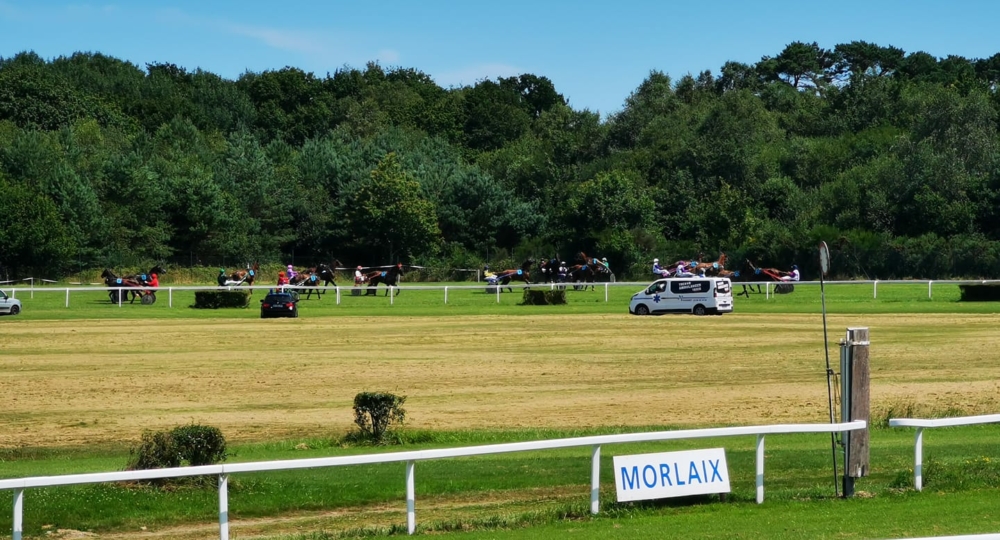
{"left": 5, "top": 282, "right": 1000, "bottom": 320}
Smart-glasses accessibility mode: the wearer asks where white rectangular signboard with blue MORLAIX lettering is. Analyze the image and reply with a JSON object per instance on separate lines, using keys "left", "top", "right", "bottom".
{"left": 614, "top": 448, "right": 730, "bottom": 502}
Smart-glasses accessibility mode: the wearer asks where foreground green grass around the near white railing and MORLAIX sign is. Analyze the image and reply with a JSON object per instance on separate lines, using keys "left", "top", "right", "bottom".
{"left": 0, "top": 426, "right": 1000, "bottom": 538}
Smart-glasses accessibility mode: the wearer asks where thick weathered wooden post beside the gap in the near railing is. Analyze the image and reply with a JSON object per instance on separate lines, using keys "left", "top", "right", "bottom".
{"left": 841, "top": 328, "right": 871, "bottom": 497}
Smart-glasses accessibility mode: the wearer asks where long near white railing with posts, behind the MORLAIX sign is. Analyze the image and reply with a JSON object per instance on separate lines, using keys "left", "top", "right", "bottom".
{"left": 0, "top": 420, "right": 867, "bottom": 540}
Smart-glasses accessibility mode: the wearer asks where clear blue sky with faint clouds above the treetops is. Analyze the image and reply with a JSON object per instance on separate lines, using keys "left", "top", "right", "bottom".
{"left": 0, "top": 0, "right": 1000, "bottom": 115}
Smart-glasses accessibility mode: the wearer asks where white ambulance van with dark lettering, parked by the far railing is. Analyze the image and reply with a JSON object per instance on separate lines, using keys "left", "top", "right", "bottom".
{"left": 628, "top": 277, "right": 733, "bottom": 315}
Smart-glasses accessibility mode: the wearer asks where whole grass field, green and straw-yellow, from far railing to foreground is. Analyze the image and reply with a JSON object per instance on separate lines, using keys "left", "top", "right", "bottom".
{"left": 0, "top": 285, "right": 1000, "bottom": 538}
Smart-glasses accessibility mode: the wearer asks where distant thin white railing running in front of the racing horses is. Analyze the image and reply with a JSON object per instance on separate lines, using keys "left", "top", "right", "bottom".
{"left": 9, "top": 279, "right": 1000, "bottom": 307}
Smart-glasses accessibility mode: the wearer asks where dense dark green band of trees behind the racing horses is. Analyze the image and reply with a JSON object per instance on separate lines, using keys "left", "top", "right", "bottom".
{"left": 0, "top": 42, "right": 1000, "bottom": 279}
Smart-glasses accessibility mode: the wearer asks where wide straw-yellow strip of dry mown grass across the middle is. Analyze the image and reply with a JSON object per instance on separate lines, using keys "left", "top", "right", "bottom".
{"left": 0, "top": 313, "right": 1000, "bottom": 448}
